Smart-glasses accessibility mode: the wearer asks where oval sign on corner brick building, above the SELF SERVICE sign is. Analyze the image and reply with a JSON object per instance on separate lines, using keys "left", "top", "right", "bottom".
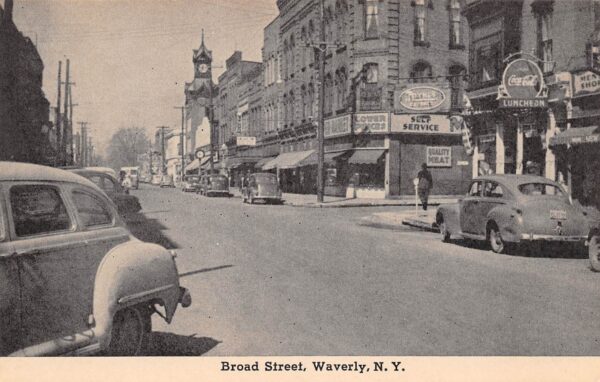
{"left": 394, "top": 84, "right": 450, "bottom": 113}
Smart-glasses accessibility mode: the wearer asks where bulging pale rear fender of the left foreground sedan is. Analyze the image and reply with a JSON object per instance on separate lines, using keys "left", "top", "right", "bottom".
{"left": 93, "top": 240, "right": 180, "bottom": 348}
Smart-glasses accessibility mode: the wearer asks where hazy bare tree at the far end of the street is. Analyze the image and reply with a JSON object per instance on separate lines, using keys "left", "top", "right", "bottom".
{"left": 106, "top": 127, "right": 150, "bottom": 169}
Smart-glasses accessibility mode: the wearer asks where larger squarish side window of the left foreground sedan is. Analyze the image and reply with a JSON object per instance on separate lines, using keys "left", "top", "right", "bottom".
{"left": 10, "top": 185, "right": 72, "bottom": 236}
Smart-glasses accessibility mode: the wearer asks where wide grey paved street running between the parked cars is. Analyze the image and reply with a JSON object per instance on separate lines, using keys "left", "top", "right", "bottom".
{"left": 131, "top": 185, "right": 600, "bottom": 356}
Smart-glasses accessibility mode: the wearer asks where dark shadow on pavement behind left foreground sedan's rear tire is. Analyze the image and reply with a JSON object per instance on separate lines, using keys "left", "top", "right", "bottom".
{"left": 142, "top": 332, "right": 220, "bottom": 357}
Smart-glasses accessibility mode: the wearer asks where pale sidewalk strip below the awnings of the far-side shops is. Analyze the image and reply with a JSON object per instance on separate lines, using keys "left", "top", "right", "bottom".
{"left": 230, "top": 188, "right": 458, "bottom": 209}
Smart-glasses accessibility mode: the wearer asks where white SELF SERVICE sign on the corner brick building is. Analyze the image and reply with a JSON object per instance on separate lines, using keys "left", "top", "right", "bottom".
{"left": 390, "top": 114, "right": 461, "bottom": 135}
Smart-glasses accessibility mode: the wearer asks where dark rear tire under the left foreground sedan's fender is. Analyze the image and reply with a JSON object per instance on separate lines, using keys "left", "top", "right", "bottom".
{"left": 107, "top": 307, "right": 152, "bottom": 357}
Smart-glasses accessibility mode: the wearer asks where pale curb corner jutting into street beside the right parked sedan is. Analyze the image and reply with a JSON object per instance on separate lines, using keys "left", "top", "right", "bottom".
{"left": 360, "top": 208, "right": 439, "bottom": 232}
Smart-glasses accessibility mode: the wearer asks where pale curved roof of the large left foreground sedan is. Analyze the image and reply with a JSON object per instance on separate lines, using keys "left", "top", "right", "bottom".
{"left": 0, "top": 161, "right": 100, "bottom": 191}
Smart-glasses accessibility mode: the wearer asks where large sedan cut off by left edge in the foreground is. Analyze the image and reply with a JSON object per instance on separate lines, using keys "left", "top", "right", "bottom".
{"left": 0, "top": 162, "right": 191, "bottom": 356}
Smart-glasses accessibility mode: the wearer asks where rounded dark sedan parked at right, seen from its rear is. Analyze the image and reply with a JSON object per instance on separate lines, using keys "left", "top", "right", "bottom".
{"left": 435, "top": 175, "right": 589, "bottom": 253}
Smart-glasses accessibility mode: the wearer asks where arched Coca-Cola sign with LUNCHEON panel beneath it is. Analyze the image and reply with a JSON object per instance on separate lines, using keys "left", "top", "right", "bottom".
{"left": 498, "top": 58, "right": 548, "bottom": 108}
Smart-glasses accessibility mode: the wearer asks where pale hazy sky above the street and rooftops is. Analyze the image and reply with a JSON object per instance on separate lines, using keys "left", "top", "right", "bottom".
{"left": 11, "top": 0, "right": 277, "bottom": 153}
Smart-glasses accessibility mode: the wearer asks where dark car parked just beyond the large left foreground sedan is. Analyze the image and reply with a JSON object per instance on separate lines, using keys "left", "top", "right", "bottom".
{"left": 69, "top": 168, "right": 142, "bottom": 217}
